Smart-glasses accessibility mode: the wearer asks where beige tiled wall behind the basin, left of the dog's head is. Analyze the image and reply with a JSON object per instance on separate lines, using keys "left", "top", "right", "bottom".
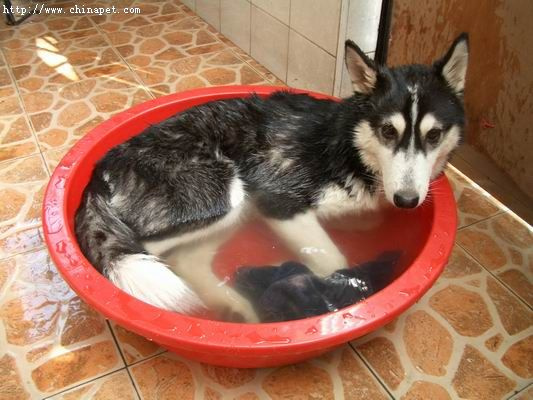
{"left": 183, "top": 0, "right": 381, "bottom": 96}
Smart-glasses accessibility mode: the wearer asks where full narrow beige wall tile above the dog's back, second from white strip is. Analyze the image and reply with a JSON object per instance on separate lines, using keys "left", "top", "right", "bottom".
{"left": 251, "top": 6, "right": 289, "bottom": 81}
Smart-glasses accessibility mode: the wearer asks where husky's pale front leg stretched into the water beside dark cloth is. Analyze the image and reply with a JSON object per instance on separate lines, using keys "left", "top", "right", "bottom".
{"left": 265, "top": 211, "right": 348, "bottom": 277}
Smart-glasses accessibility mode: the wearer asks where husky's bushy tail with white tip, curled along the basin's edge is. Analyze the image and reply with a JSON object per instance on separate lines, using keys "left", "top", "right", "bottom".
{"left": 76, "top": 191, "right": 205, "bottom": 314}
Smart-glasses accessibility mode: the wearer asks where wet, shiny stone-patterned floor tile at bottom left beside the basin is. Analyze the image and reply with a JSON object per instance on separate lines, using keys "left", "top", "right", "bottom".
{"left": 0, "top": 249, "right": 124, "bottom": 398}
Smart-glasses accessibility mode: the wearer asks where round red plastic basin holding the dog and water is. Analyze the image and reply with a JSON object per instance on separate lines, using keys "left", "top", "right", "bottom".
{"left": 43, "top": 86, "right": 457, "bottom": 368}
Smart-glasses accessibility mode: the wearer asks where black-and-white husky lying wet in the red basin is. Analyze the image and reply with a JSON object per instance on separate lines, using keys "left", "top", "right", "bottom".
{"left": 75, "top": 34, "right": 469, "bottom": 322}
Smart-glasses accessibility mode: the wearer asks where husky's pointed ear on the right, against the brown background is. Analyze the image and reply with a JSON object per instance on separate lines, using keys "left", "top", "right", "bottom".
{"left": 435, "top": 33, "right": 468, "bottom": 95}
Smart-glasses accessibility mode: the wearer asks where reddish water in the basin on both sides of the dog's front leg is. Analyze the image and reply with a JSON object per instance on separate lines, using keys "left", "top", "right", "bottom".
{"left": 213, "top": 207, "right": 432, "bottom": 279}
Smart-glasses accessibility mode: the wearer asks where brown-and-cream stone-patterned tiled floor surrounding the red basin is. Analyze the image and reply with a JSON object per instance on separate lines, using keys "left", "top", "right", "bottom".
{"left": 0, "top": 0, "right": 533, "bottom": 400}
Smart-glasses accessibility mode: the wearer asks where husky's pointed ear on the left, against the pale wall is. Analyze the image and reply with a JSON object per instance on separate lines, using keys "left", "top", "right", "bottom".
{"left": 344, "top": 40, "right": 378, "bottom": 94}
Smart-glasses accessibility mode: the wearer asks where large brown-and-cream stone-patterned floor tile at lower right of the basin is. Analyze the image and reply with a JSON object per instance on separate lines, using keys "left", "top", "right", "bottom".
{"left": 353, "top": 246, "right": 533, "bottom": 399}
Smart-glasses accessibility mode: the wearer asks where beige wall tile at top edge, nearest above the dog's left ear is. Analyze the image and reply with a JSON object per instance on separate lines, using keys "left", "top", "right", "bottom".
{"left": 290, "top": 0, "right": 341, "bottom": 55}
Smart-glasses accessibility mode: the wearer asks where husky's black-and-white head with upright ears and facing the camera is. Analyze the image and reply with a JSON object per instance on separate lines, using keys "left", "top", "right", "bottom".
{"left": 345, "top": 34, "right": 468, "bottom": 208}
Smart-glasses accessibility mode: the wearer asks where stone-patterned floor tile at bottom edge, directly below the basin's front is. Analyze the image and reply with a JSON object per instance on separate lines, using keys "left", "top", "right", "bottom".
{"left": 129, "top": 345, "right": 389, "bottom": 400}
